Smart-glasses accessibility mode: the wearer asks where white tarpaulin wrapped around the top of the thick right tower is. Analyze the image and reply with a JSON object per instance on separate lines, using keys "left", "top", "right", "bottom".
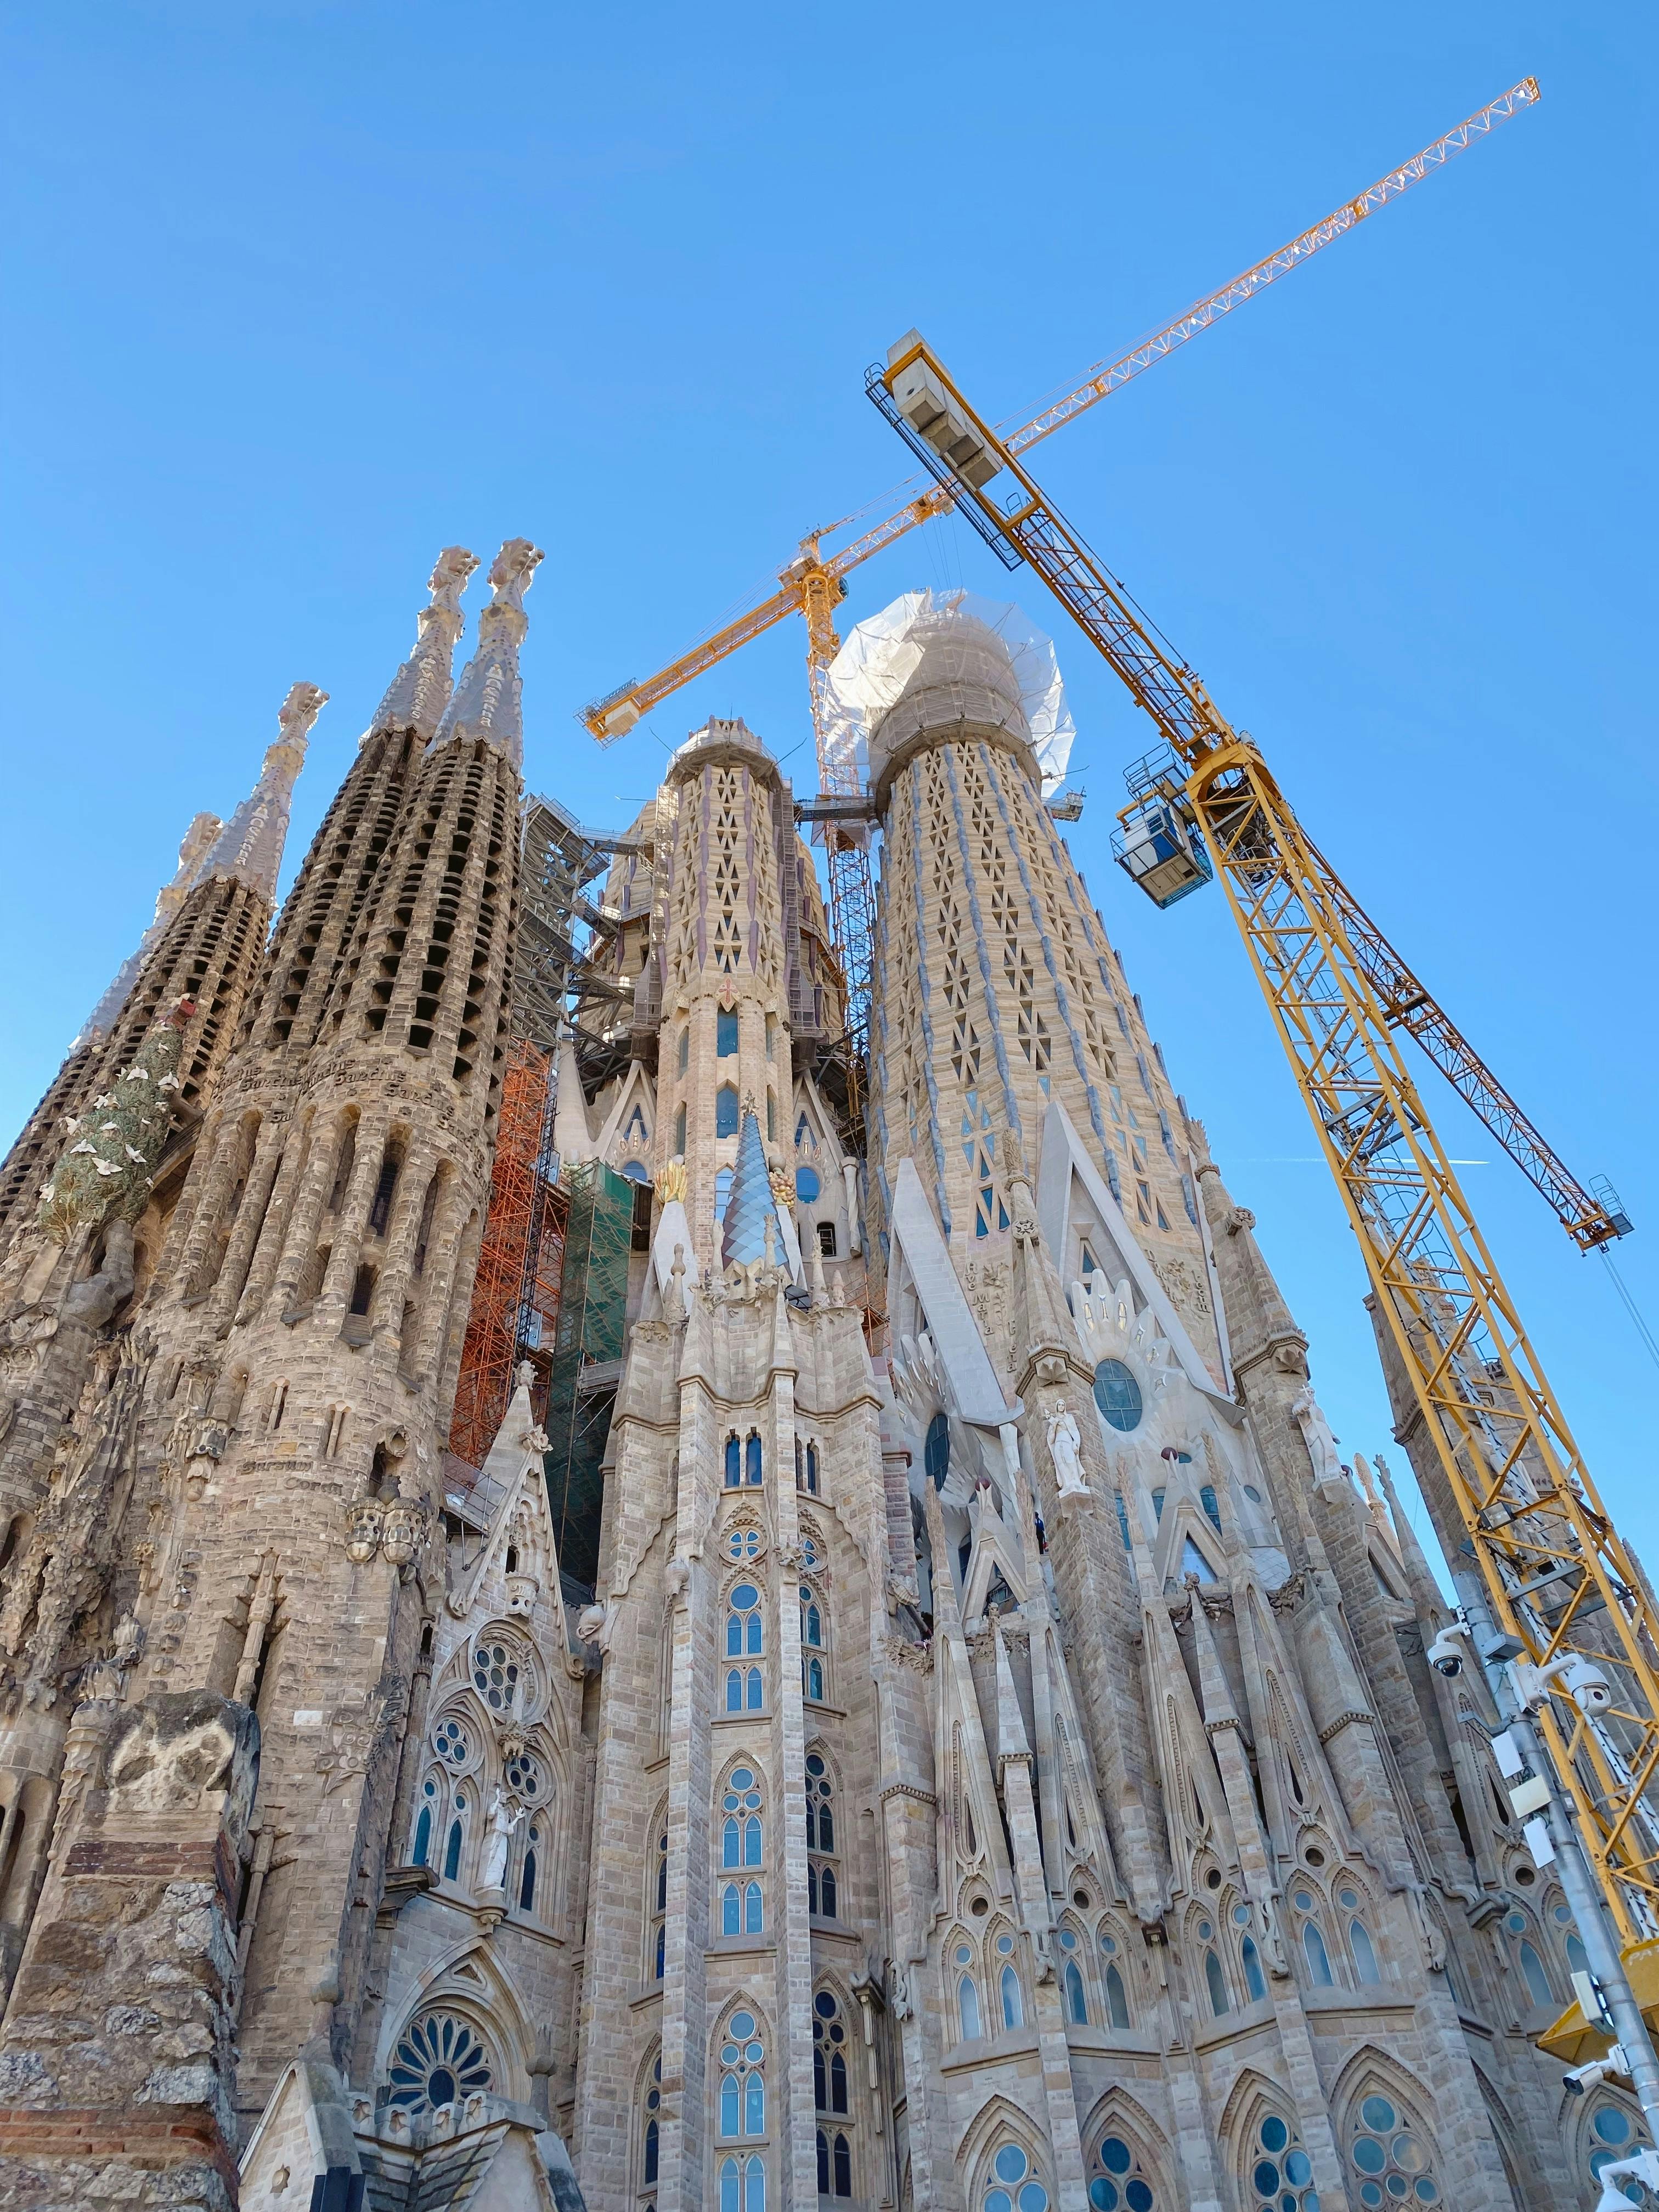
{"left": 827, "top": 591, "right": 1077, "bottom": 799}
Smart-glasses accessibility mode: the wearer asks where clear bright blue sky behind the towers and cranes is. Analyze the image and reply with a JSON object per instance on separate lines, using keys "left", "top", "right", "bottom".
{"left": 0, "top": 0, "right": 1659, "bottom": 1568}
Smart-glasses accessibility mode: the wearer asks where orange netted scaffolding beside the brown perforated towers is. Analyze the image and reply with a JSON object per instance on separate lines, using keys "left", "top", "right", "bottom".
{"left": 449, "top": 1037, "right": 571, "bottom": 1480}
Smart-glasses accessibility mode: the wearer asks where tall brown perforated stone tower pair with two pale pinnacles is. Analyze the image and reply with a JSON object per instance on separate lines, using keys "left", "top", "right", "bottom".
{"left": 0, "top": 540, "right": 553, "bottom": 2212}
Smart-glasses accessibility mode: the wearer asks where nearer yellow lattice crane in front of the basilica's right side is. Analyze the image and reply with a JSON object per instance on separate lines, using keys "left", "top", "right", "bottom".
{"left": 867, "top": 332, "right": 1659, "bottom": 1944}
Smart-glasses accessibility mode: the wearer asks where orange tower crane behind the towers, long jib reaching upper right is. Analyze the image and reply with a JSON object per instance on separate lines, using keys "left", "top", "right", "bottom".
{"left": 577, "top": 77, "right": 1537, "bottom": 1115}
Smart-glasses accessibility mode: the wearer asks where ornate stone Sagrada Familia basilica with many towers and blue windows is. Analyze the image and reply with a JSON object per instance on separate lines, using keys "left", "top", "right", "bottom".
{"left": 0, "top": 540, "right": 1639, "bottom": 2212}
